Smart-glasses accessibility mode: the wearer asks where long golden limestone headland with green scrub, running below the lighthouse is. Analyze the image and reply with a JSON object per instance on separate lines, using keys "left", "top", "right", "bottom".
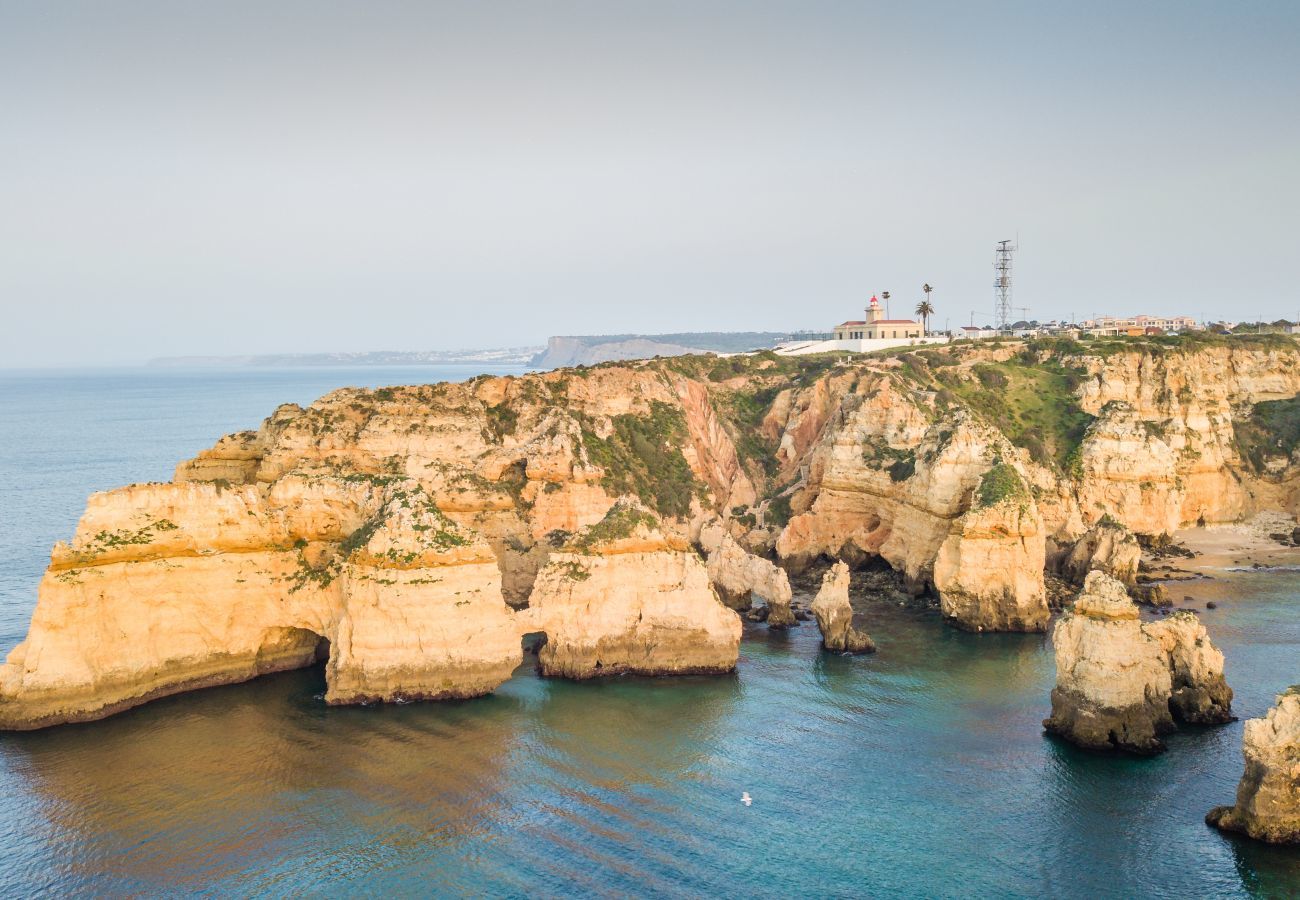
{"left": 0, "top": 336, "right": 1300, "bottom": 727}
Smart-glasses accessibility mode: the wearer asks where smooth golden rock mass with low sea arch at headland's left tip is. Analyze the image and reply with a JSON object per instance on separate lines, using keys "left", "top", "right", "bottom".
{"left": 0, "top": 476, "right": 520, "bottom": 728}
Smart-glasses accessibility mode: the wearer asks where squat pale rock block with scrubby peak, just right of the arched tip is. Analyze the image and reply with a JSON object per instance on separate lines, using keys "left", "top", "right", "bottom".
{"left": 520, "top": 502, "right": 741, "bottom": 679}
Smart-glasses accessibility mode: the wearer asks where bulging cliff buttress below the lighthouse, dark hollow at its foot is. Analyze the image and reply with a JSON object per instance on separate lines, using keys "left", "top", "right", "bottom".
{"left": 777, "top": 378, "right": 1048, "bottom": 631}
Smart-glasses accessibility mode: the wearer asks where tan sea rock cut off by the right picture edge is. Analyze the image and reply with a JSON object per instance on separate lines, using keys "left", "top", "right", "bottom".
{"left": 1205, "top": 687, "right": 1300, "bottom": 844}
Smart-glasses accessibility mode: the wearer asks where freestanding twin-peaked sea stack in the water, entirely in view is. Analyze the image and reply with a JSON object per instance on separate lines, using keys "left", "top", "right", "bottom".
{"left": 1043, "top": 571, "right": 1232, "bottom": 754}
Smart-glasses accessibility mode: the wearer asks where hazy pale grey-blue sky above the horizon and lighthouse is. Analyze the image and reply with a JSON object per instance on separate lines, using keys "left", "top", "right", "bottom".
{"left": 0, "top": 0, "right": 1300, "bottom": 365}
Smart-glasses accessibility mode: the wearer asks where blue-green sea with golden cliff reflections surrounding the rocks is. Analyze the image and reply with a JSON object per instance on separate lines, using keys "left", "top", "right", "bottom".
{"left": 0, "top": 367, "right": 1300, "bottom": 897}
